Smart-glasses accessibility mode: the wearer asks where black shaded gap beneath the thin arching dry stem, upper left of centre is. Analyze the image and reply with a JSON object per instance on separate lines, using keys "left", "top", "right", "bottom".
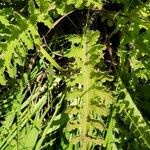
{"left": 38, "top": 10, "right": 87, "bottom": 41}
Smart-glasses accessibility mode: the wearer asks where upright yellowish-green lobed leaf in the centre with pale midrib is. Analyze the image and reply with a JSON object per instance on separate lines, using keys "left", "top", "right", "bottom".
{"left": 65, "top": 30, "right": 112, "bottom": 150}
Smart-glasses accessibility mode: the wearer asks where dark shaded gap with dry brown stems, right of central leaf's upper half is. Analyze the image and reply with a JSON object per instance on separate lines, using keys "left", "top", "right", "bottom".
{"left": 91, "top": 11, "right": 121, "bottom": 74}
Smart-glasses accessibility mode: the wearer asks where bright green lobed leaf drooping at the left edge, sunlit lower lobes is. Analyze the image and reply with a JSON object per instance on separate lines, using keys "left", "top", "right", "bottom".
{"left": 0, "top": 9, "right": 37, "bottom": 84}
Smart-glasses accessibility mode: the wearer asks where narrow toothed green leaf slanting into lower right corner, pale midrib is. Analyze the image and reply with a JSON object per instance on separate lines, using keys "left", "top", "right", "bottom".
{"left": 119, "top": 85, "right": 150, "bottom": 148}
